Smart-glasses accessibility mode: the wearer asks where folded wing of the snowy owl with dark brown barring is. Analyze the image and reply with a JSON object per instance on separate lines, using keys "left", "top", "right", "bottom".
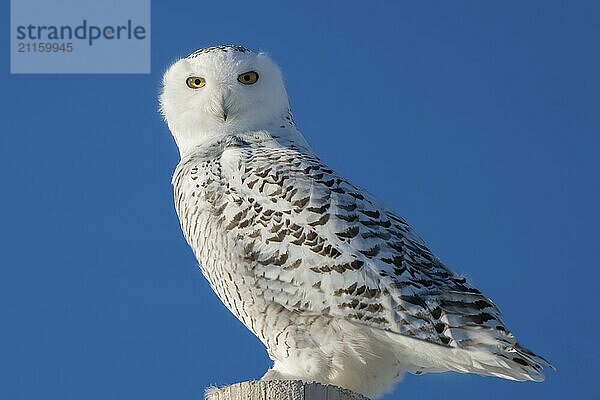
{"left": 188, "top": 134, "right": 541, "bottom": 379}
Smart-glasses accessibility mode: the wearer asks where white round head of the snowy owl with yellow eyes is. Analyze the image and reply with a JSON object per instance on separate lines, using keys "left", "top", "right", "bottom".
{"left": 160, "top": 46, "right": 289, "bottom": 153}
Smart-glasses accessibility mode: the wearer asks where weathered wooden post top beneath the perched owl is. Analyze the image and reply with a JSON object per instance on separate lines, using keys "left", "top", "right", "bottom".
{"left": 205, "top": 381, "right": 369, "bottom": 400}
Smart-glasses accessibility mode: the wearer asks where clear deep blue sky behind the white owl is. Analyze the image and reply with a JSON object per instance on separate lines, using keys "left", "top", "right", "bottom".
{"left": 0, "top": 1, "right": 600, "bottom": 400}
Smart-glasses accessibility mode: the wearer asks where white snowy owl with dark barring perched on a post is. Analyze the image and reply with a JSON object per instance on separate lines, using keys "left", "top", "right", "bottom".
{"left": 160, "top": 46, "right": 550, "bottom": 397}
